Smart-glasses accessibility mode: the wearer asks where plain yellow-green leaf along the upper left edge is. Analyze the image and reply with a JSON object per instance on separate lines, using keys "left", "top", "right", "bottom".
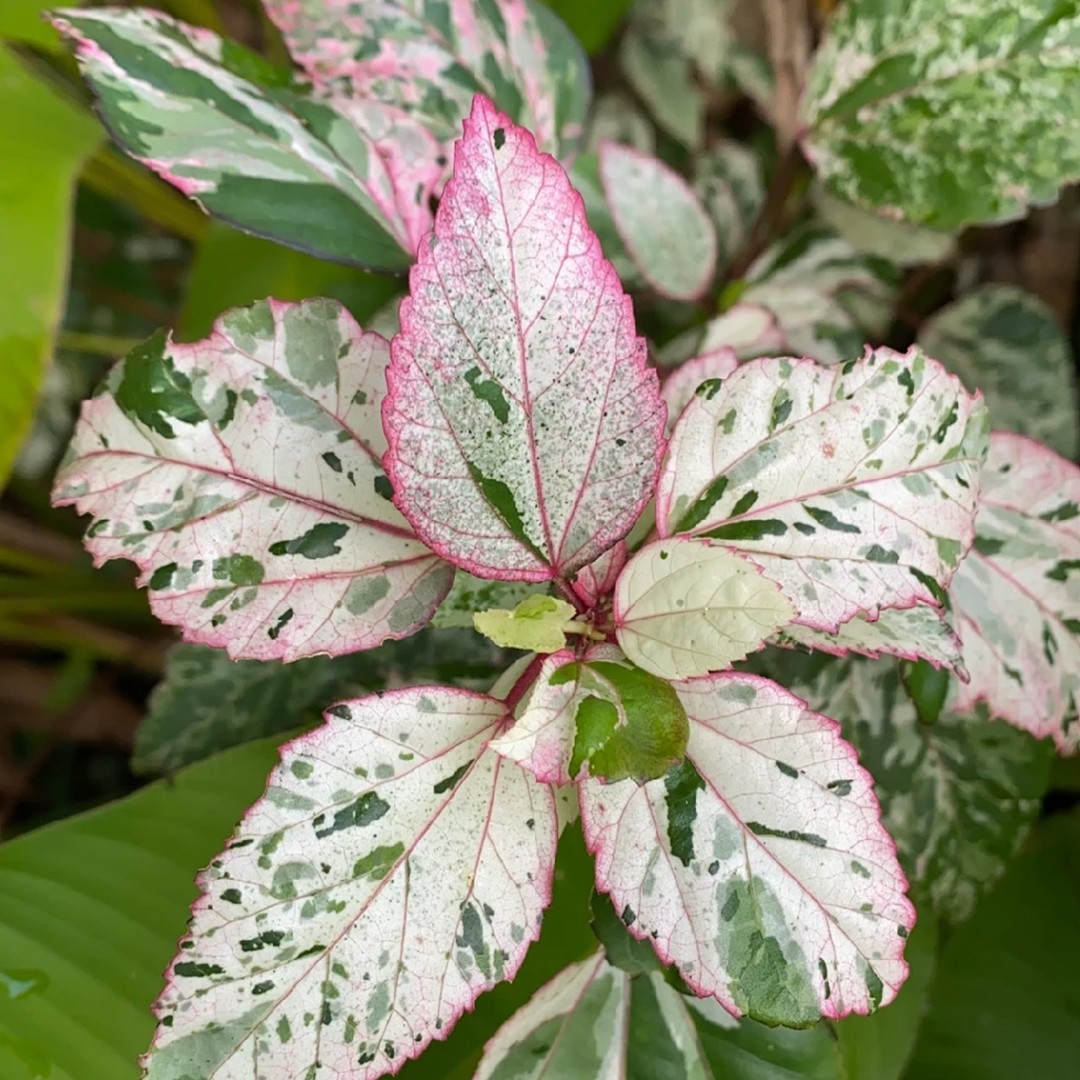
{"left": 0, "top": 48, "right": 100, "bottom": 487}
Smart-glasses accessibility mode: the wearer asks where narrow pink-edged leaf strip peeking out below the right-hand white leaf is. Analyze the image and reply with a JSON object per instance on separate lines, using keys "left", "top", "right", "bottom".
{"left": 778, "top": 609, "right": 968, "bottom": 678}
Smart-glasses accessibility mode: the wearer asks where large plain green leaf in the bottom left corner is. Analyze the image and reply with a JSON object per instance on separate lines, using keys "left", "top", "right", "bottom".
{"left": 0, "top": 742, "right": 276, "bottom": 1080}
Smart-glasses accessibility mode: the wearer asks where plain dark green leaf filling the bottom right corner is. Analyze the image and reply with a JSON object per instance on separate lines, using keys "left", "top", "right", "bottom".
{"left": 906, "top": 812, "right": 1080, "bottom": 1080}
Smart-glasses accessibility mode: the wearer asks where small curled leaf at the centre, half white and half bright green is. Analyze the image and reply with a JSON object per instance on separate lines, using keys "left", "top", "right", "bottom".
{"left": 491, "top": 645, "right": 687, "bottom": 784}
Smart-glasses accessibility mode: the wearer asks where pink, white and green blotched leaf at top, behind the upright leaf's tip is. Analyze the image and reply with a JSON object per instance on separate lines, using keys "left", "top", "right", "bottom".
{"left": 265, "top": 0, "right": 591, "bottom": 156}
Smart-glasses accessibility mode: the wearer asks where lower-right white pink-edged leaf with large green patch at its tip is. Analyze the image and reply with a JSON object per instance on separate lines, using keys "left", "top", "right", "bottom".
{"left": 580, "top": 674, "right": 915, "bottom": 1025}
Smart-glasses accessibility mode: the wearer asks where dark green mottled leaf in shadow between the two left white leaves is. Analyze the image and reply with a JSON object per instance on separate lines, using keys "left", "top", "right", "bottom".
{"left": 132, "top": 627, "right": 501, "bottom": 773}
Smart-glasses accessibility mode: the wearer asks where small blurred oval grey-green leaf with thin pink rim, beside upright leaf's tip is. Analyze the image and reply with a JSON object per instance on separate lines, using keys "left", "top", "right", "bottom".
{"left": 599, "top": 143, "right": 716, "bottom": 300}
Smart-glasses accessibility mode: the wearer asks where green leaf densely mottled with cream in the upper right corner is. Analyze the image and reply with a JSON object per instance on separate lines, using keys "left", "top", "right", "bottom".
{"left": 804, "top": 0, "right": 1080, "bottom": 229}
